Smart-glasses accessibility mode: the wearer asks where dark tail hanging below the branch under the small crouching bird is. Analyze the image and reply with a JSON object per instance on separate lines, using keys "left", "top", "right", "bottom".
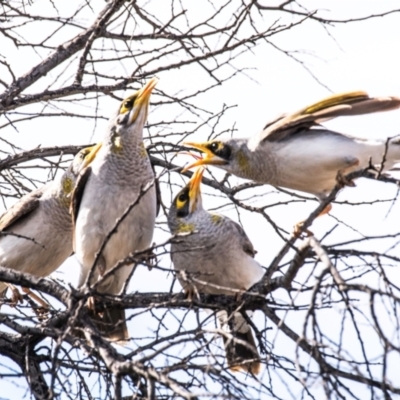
{"left": 218, "top": 311, "right": 261, "bottom": 375}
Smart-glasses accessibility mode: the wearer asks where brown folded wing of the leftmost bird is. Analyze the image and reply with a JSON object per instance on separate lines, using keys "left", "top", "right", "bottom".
{"left": 0, "top": 185, "right": 47, "bottom": 232}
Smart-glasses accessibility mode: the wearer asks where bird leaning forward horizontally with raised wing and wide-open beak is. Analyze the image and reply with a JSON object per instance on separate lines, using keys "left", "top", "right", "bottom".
{"left": 183, "top": 91, "right": 400, "bottom": 212}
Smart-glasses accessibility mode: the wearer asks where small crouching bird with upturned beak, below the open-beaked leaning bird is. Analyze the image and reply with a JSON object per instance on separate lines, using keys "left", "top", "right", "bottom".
{"left": 168, "top": 168, "right": 265, "bottom": 374}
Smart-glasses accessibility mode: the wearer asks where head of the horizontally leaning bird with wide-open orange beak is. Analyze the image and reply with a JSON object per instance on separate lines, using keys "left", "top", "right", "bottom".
{"left": 182, "top": 140, "right": 235, "bottom": 172}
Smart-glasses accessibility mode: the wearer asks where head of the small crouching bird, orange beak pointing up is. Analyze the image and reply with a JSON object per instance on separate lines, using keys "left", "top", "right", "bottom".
{"left": 170, "top": 168, "right": 204, "bottom": 223}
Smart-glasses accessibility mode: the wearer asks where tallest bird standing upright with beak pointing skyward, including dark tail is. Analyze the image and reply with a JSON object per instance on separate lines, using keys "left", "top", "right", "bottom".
{"left": 71, "top": 78, "right": 158, "bottom": 344}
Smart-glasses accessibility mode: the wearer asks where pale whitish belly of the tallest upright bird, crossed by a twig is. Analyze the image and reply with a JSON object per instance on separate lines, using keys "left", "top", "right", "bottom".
{"left": 74, "top": 179, "right": 156, "bottom": 294}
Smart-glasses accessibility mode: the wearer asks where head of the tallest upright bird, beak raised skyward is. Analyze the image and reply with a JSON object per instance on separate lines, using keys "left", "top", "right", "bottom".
{"left": 107, "top": 77, "right": 158, "bottom": 147}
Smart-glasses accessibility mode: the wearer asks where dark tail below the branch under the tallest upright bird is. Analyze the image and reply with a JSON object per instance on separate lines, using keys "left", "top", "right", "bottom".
{"left": 89, "top": 307, "right": 129, "bottom": 342}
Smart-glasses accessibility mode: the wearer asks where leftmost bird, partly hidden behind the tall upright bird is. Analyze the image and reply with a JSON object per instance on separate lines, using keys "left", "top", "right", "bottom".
{"left": 0, "top": 144, "right": 101, "bottom": 307}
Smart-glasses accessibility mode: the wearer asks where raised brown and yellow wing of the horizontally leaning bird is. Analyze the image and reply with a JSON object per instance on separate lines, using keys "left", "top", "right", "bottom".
{"left": 249, "top": 91, "right": 400, "bottom": 150}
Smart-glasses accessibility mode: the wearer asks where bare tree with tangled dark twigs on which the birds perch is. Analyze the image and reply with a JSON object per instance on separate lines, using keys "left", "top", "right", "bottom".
{"left": 0, "top": 0, "right": 400, "bottom": 399}
